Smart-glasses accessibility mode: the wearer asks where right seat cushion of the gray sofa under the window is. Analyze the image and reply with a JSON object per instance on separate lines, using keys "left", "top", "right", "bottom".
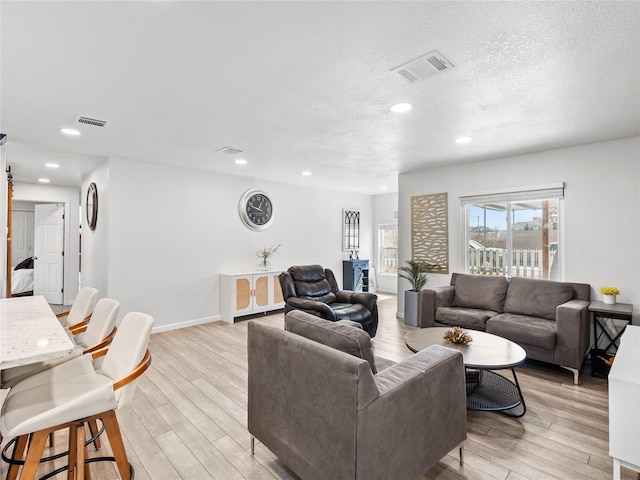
{"left": 487, "top": 313, "right": 556, "bottom": 350}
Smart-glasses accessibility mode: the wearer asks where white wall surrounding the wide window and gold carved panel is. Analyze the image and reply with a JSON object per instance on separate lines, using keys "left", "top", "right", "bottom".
{"left": 398, "top": 137, "right": 640, "bottom": 323}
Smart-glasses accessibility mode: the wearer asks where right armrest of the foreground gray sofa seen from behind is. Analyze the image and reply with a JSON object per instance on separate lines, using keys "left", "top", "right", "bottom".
{"left": 355, "top": 346, "right": 467, "bottom": 478}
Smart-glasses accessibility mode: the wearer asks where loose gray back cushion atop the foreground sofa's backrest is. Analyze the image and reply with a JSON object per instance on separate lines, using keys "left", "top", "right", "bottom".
{"left": 284, "top": 310, "right": 378, "bottom": 373}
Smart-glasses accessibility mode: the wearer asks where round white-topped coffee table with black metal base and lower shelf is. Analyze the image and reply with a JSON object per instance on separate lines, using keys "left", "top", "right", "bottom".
{"left": 404, "top": 327, "right": 527, "bottom": 417}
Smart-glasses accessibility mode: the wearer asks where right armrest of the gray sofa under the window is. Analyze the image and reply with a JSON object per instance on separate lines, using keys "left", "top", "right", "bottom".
{"left": 555, "top": 300, "right": 591, "bottom": 369}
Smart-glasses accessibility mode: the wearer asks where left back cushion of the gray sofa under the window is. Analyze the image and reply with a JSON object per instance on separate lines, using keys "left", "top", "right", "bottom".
{"left": 451, "top": 273, "right": 509, "bottom": 313}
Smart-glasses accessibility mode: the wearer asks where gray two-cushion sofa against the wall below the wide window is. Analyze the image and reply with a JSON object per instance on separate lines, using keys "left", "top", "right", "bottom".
{"left": 420, "top": 273, "right": 591, "bottom": 384}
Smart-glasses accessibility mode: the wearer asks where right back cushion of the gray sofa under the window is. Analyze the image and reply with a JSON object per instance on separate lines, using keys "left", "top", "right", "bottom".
{"left": 504, "top": 277, "right": 573, "bottom": 320}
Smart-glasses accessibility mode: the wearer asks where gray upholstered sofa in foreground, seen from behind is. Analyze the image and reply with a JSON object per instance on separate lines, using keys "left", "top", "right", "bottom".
{"left": 248, "top": 310, "right": 467, "bottom": 480}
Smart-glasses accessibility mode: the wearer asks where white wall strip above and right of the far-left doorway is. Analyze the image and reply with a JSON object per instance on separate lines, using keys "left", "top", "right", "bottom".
{"left": 13, "top": 183, "right": 80, "bottom": 305}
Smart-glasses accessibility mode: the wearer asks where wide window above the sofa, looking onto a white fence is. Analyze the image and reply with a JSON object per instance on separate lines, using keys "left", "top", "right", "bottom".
{"left": 461, "top": 186, "right": 564, "bottom": 280}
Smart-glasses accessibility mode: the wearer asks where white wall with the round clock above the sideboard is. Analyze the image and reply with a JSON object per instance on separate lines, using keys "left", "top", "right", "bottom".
{"left": 82, "top": 158, "right": 373, "bottom": 331}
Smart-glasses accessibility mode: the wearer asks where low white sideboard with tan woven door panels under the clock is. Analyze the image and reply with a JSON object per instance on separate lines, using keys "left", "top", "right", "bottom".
{"left": 220, "top": 270, "right": 284, "bottom": 323}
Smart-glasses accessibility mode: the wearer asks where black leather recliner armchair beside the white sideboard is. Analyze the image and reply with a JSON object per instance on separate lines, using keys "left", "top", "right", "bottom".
{"left": 278, "top": 265, "right": 378, "bottom": 337}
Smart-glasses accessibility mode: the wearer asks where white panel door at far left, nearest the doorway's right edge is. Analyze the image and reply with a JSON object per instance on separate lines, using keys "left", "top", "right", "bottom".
{"left": 33, "top": 204, "right": 64, "bottom": 304}
